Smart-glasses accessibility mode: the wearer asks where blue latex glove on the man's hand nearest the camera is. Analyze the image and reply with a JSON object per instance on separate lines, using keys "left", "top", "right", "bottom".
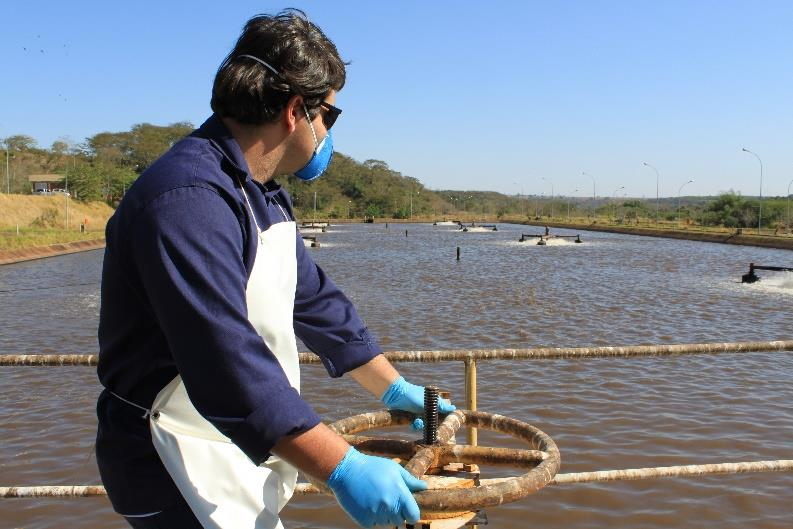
{"left": 328, "top": 447, "right": 427, "bottom": 529}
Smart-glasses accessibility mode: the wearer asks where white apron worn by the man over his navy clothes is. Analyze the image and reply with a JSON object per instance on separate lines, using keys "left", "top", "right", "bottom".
{"left": 149, "top": 189, "right": 300, "bottom": 529}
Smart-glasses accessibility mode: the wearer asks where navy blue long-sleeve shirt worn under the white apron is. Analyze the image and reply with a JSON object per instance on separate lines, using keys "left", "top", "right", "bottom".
{"left": 97, "top": 116, "right": 381, "bottom": 514}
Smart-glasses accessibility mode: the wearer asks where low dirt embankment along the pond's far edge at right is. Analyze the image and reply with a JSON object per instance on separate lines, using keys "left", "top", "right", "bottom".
{"left": 526, "top": 222, "right": 793, "bottom": 250}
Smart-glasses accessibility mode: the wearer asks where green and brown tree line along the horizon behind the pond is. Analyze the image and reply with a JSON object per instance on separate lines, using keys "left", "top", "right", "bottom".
{"left": 2, "top": 126, "right": 790, "bottom": 228}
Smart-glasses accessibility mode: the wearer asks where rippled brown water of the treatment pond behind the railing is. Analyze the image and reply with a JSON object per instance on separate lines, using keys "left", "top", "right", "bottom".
{"left": 0, "top": 224, "right": 793, "bottom": 529}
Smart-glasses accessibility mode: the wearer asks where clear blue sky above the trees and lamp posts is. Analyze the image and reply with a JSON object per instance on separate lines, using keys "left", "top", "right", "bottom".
{"left": 0, "top": 0, "right": 793, "bottom": 197}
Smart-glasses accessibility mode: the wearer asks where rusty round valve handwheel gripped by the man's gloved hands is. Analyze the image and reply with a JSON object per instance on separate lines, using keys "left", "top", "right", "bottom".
{"left": 330, "top": 410, "right": 560, "bottom": 516}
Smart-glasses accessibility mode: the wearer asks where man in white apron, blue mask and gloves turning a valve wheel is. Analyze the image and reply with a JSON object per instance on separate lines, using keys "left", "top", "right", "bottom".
{"left": 96, "top": 11, "right": 454, "bottom": 529}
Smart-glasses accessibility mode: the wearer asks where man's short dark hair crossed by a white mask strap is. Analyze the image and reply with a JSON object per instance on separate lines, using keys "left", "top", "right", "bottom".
{"left": 211, "top": 9, "right": 346, "bottom": 125}
